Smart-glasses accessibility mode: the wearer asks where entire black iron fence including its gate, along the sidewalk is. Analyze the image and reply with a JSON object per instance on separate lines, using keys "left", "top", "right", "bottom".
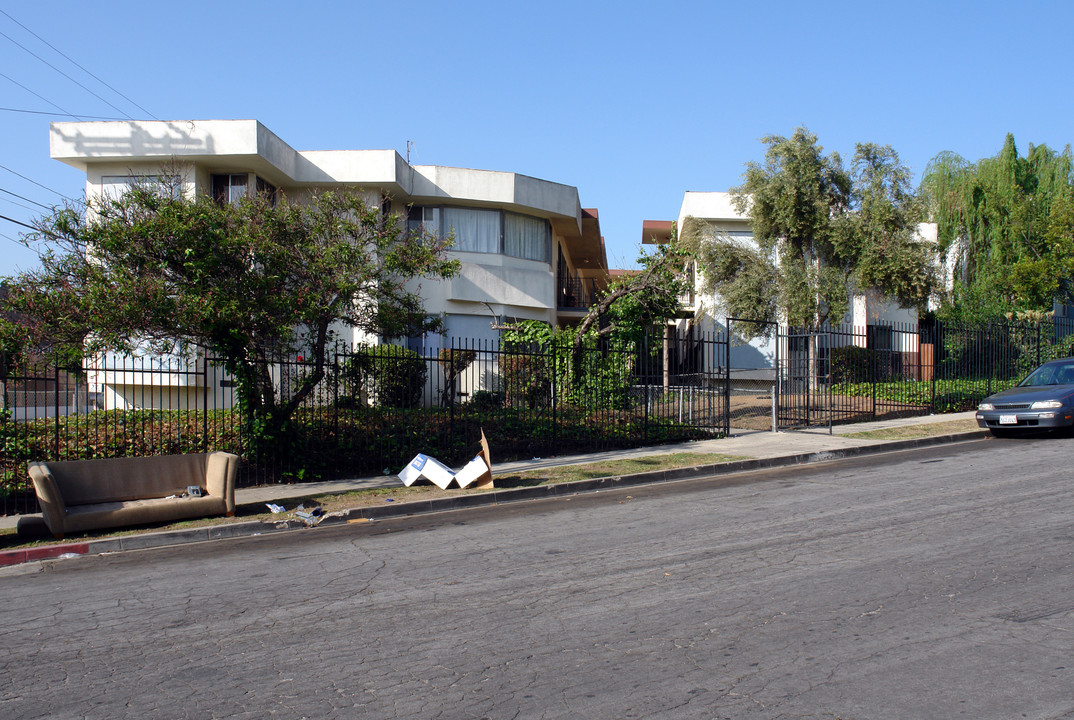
{"left": 6, "top": 320, "right": 1074, "bottom": 514}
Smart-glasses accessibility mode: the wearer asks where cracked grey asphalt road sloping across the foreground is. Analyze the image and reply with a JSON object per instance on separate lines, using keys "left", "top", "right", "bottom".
{"left": 0, "top": 440, "right": 1074, "bottom": 720}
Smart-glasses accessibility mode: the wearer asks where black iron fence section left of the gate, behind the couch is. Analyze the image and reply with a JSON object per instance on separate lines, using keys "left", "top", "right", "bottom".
{"left": 0, "top": 336, "right": 727, "bottom": 514}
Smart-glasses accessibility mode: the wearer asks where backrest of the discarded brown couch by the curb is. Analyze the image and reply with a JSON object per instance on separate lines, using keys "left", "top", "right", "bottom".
{"left": 46, "top": 452, "right": 208, "bottom": 506}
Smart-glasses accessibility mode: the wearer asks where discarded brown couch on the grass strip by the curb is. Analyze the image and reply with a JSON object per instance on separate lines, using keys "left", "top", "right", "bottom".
{"left": 29, "top": 452, "right": 238, "bottom": 538}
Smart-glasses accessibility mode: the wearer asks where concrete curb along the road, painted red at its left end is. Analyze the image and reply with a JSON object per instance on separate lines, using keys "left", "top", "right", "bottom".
{"left": 0, "top": 430, "right": 989, "bottom": 567}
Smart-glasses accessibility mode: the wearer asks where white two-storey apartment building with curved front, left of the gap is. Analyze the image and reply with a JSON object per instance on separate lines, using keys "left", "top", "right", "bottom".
{"left": 49, "top": 120, "right": 608, "bottom": 406}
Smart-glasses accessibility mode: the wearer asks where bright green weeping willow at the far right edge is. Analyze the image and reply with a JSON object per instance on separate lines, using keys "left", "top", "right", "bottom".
{"left": 920, "top": 134, "right": 1074, "bottom": 318}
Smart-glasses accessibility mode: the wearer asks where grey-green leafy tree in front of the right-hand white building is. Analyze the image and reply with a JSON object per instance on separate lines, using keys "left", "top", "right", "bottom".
{"left": 682, "top": 128, "right": 935, "bottom": 334}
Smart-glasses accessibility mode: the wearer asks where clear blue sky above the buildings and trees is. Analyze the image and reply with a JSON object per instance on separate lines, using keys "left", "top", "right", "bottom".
{"left": 0, "top": 0, "right": 1074, "bottom": 275}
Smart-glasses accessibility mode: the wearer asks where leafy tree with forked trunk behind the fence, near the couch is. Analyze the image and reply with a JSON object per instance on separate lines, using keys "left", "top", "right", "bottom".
{"left": 0, "top": 186, "right": 458, "bottom": 438}
